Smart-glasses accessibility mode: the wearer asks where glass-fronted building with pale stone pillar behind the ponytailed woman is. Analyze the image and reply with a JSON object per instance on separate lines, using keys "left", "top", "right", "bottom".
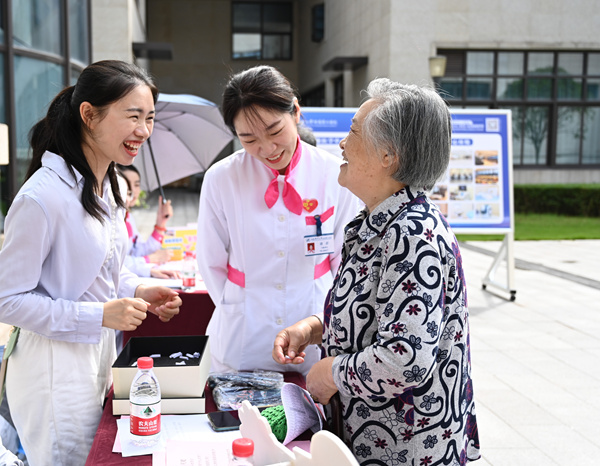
{"left": 0, "top": 0, "right": 146, "bottom": 226}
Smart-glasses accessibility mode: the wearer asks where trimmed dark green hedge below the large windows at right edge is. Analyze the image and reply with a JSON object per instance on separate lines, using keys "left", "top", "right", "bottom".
{"left": 514, "top": 184, "right": 600, "bottom": 217}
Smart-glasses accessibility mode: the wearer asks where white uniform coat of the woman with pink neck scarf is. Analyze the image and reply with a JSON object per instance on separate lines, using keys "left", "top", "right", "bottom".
{"left": 196, "top": 142, "right": 360, "bottom": 374}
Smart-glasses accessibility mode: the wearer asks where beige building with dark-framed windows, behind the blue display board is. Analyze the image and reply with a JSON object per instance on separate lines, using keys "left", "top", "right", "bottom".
{"left": 147, "top": 0, "right": 600, "bottom": 183}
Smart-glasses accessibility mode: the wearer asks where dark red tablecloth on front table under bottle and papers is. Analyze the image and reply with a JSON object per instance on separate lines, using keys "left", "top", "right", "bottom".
{"left": 85, "top": 372, "right": 306, "bottom": 466}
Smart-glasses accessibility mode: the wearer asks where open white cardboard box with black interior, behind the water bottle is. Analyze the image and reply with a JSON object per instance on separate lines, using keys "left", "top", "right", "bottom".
{"left": 112, "top": 335, "right": 210, "bottom": 399}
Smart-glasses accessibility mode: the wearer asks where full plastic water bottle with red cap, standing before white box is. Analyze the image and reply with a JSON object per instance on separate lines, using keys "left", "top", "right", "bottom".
{"left": 129, "top": 357, "right": 160, "bottom": 446}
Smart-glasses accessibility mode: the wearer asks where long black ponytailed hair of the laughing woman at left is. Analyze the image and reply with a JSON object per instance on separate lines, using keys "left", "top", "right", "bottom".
{"left": 25, "top": 60, "right": 158, "bottom": 222}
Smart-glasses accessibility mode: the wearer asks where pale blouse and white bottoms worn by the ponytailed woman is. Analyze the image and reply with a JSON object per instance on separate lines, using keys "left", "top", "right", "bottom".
{"left": 0, "top": 152, "right": 140, "bottom": 466}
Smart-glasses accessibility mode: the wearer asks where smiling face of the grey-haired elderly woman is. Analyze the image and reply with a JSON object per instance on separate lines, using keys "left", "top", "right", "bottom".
{"left": 338, "top": 100, "right": 387, "bottom": 206}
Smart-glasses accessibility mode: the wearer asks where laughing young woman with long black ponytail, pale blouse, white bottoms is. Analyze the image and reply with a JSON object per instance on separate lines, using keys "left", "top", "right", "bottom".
{"left": 0, "top": 60, "right": 181, "bottom": 466}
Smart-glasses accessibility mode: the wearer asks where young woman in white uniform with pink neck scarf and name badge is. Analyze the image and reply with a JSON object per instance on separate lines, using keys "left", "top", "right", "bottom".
{"left": 196, "top": 66, "right": 360, "bottom": 374}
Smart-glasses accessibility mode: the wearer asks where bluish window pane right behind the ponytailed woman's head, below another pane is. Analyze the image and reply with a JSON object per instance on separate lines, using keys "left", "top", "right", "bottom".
{"left": 15, "top": 55, "right": 64, "bottom": 185}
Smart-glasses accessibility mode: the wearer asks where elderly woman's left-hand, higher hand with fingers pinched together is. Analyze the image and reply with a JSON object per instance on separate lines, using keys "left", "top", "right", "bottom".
{"left": 272, "top": 316, "right": 323, "bottom": 364}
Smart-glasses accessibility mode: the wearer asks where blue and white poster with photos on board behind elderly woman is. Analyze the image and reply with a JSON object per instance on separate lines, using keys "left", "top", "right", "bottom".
{"left": 302, "top": 107, "right": 513, "bottom": 234}
